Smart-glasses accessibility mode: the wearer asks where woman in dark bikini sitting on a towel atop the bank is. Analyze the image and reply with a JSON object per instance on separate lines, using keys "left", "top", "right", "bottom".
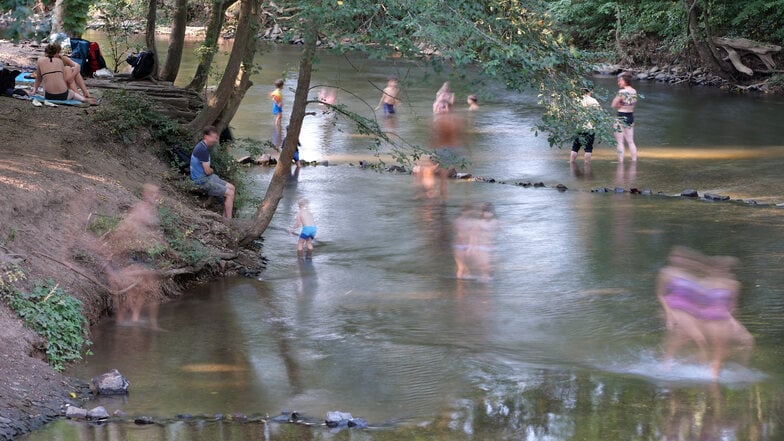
{"left": 33, "top": 43, "right": 98, "bottom": 106}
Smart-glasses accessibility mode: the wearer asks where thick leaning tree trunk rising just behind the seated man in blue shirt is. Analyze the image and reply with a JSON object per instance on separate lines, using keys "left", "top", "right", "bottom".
{"left": 186, "top": 0, "right": 256, "bottom": 133}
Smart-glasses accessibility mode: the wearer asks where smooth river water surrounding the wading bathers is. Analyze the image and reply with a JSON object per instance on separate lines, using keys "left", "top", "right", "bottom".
{"left": 21, "top": 36, "right": 784, "bottom": 440}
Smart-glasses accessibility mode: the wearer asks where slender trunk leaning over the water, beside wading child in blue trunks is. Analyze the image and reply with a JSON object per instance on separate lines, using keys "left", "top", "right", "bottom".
{"left": 239, "top": 24, "right": 318, "bottom": 246}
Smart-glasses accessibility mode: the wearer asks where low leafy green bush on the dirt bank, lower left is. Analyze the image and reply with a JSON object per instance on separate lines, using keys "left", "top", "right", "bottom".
{"left": 4, "top": 280, "right": 92, "bottom": 371}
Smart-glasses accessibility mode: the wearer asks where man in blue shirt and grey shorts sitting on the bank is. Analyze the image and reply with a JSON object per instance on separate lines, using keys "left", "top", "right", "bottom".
{"left": 191, "top": 126, "right": 234, "bottom": 219}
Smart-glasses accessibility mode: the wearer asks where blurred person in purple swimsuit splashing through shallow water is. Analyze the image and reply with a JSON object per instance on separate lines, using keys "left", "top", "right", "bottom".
{"left": 656, "top": 247, "right": 754, "bottom": 379}
